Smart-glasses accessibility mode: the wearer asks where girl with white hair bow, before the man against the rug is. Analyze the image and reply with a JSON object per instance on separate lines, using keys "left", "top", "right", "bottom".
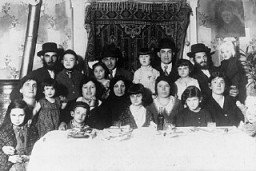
{"left": 92, "top": 62, "right": 110, "bottom": 100}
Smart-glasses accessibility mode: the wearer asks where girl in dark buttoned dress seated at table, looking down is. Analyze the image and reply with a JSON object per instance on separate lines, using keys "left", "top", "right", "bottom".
{"left": 176, "top": 86, "right": 212, "bottom": 127}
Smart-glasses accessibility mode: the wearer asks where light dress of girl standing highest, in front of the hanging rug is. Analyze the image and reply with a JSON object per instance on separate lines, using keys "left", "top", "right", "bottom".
{"left": 133, "top": 66, "right": 160, "bottom": 93}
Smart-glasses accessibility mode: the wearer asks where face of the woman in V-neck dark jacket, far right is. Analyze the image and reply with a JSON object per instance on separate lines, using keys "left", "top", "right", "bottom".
{"left": 210, "top": 77, "right": 226, "bottom": 95}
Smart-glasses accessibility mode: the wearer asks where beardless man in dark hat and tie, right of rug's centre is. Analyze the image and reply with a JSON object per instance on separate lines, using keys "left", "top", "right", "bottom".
{"left": 155, "top": 38, "right": 178, "bottom": 83}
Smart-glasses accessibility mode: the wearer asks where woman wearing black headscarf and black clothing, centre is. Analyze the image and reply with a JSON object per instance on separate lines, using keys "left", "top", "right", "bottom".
{"left": 106, "top": 76, "right": 131, "bottom": 123}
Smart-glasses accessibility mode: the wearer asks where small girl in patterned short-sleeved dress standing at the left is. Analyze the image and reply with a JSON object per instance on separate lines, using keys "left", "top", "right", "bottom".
{"left": 33, "top": 79, "right": 67, "bottom": 137}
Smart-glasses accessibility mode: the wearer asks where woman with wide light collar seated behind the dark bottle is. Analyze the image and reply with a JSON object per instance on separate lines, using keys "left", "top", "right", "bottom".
{"left": 147, "top": 76, "right": 182, "bottom": 124}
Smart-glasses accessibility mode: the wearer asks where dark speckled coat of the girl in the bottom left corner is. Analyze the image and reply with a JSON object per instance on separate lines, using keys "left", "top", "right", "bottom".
{"left": 0, "top": 121, "right": 38, "bottom": 171}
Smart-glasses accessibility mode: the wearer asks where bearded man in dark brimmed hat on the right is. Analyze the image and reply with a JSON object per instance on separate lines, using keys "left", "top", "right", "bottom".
{"left": 187, "top": 43, "right": 216, "bottom": 100}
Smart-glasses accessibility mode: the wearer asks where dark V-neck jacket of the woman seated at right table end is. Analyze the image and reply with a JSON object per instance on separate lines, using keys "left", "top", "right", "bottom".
{"left": 205, "top": 96, "right": 244, "bottom": 126}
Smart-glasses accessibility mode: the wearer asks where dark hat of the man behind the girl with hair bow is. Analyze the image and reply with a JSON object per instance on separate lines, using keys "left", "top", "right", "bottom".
{"left": 101, "top": 44, "right": 122, "bottom": 59}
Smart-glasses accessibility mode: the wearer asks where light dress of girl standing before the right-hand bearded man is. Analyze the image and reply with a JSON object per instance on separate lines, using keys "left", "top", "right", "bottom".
{"left": 175, "top": 77, "right": 200, "bottom": 100}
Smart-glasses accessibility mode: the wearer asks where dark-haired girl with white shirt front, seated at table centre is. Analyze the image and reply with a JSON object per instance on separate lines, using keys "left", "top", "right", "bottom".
{"left": 120, "top": 84, "right": 152, "bottom": 129}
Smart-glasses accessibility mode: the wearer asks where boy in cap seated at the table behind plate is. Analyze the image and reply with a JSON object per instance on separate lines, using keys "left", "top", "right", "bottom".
{"left": 67, "top": 101, "right": 90, "bottom": 129}
